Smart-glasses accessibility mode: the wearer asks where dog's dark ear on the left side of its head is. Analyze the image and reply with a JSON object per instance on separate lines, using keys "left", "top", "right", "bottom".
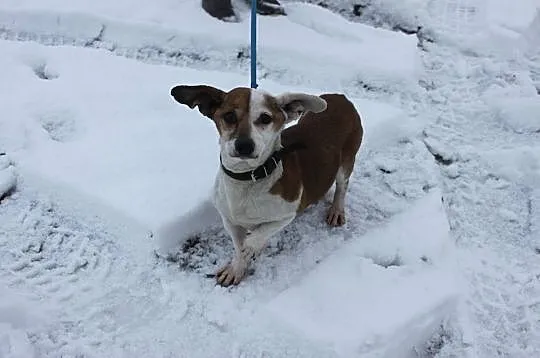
{"left": 171, "top": 85, "right": 225, "bottom": 119}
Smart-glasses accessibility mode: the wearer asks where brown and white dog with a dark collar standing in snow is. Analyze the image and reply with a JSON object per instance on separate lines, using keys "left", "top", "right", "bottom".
{"left": 171, "top": 85, "right": 363, "bottom": 286}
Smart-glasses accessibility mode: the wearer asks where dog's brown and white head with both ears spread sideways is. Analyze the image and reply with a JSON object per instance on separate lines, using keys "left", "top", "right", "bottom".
{"left": 171, "top": 86, "right": 326, "bottom": 172}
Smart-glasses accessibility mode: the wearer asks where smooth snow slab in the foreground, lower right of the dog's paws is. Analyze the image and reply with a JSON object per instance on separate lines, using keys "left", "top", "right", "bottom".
{"left": 265, "top": 190, "right": 458, "bottom": 358}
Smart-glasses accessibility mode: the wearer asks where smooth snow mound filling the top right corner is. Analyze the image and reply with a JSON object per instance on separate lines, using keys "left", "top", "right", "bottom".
{"left": 342, "top": 0, "right": 540, "bottom": 55}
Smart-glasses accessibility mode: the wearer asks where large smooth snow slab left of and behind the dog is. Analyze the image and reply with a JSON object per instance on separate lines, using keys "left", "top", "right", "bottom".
{"left": 0, "top": 42, "right": 410, "bottom": 239}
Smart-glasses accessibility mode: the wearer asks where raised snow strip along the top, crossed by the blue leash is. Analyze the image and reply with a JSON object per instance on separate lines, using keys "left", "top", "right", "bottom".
{"left": 0, "top": 0, "right": 419, "bottom": 91}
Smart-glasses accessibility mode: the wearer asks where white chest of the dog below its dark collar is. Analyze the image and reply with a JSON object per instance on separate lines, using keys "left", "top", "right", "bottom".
{"left": 214, "top": 171, "right": 299, "bottom": 227}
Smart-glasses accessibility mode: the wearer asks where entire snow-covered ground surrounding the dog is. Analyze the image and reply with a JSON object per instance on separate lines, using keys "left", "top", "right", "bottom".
{"left": 0, "top": 0, "right": 540, "bottom": 357}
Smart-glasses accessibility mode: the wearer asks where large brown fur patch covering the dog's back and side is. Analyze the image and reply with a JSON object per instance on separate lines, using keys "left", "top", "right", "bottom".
{"left": 275, "top": 94, "right": 363, "bottom": 211}
